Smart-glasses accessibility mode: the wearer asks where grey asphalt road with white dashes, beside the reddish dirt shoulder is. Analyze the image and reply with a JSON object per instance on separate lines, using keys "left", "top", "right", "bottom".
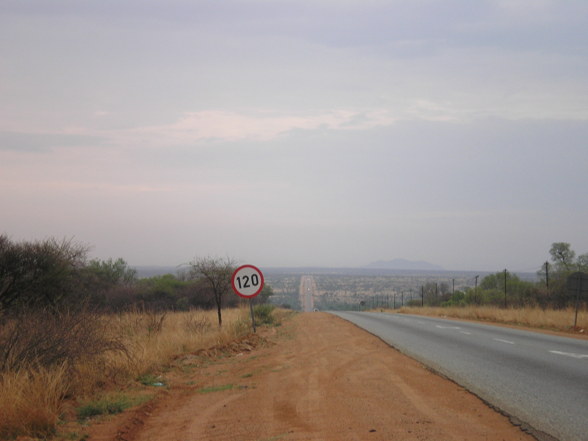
{"left": 334, "top": 312, "right": 588, "bottom": 441}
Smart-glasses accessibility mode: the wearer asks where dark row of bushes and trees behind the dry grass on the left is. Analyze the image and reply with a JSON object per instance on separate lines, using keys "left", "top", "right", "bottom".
{"left": 0, "top": 234, "right": 272, "bottom": 324}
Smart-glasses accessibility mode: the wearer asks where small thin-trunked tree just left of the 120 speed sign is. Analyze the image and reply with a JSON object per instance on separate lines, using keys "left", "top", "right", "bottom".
{"left": 190, "top": 257, "right": 236, "bottom": 327}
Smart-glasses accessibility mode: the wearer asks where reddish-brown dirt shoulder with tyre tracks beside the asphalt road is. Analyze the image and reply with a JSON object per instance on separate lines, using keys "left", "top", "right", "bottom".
{"left": 90, "top": 313, "right": 533, "bottom": 441}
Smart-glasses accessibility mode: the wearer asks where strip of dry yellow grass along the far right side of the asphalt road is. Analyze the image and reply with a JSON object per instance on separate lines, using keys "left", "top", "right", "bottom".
{"left": 398, "top": 306, "right": 588, "bottom": 334}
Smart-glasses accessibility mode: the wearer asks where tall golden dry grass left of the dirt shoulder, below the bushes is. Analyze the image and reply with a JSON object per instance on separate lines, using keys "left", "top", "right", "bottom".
{"left": 0, "top": 309, "right": 250, "bottom": 439}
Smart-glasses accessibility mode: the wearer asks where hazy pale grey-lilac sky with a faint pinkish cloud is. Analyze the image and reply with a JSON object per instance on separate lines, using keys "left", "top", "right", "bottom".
{"left": 0, "top": 0, "right": 588, "bottom": 271}
